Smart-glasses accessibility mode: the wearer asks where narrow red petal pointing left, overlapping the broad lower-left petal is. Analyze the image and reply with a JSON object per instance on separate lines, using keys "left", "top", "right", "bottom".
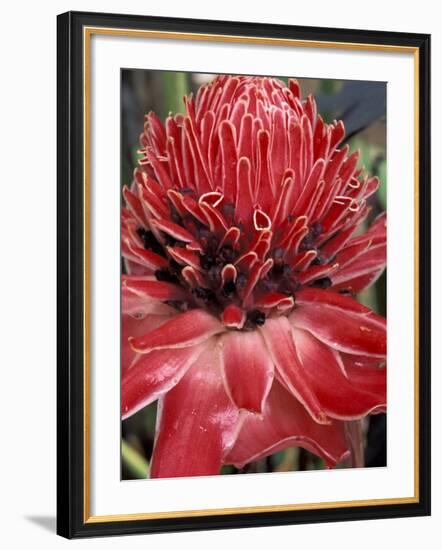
{"left": 130, "top": 309, "right": 224, "bottom": 353}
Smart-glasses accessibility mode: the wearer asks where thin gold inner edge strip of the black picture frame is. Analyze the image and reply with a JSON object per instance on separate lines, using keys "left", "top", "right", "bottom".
{"left": 83, "top": 27, "right": 419, "bottom": 524}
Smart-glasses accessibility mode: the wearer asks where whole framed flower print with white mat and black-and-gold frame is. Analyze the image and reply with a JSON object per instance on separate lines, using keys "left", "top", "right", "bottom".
{"left": 57, "top": 12, "right": 430, "bottom": 538}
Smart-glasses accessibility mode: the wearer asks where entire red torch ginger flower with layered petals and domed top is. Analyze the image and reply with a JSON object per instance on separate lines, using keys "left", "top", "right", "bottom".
{"left": 122, "top": 76, "right": 386, "bottom": 477}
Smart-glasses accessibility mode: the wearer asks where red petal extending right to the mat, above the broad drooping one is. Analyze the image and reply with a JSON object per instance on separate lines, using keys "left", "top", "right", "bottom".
{"left": 290, "top": 293, "right": 387, "bottom": 357}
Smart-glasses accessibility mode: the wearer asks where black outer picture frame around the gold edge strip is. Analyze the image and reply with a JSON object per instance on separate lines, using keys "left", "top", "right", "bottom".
{"left": 57, "top": 12, "right": 431, "bottom": 538}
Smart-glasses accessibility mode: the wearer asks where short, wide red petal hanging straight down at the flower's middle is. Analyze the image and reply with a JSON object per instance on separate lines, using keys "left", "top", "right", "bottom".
{"left": 221, "top": 331, "right": 274, "bottom": 412}
